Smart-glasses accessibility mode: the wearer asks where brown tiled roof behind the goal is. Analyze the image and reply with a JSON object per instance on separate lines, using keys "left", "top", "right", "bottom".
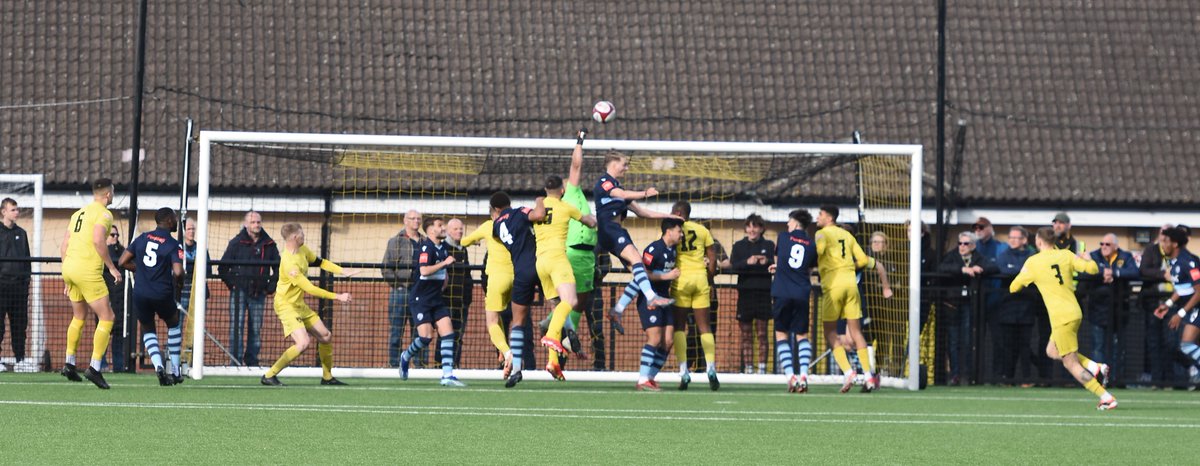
{"left": 0, "top": 0, "right": 1200, "bottom": 205}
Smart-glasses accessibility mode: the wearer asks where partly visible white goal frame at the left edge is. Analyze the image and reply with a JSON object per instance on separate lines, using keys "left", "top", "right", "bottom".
{"left": 0, "top": 174, "right": 46, "bottom": 369}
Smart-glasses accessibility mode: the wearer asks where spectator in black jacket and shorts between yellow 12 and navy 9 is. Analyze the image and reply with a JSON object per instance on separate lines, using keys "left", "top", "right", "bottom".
{"left": 730, "top": 214, "right": 775, "bottom": 374}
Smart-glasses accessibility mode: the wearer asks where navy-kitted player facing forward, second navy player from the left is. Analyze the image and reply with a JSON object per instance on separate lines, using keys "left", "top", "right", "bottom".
{"left": 400, "top": 216, "right": 467, "bottom": 387}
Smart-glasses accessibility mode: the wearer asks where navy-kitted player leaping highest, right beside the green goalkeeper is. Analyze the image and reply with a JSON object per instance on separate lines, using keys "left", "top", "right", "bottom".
{"left": 592, "top": 151, "right": 674, "bottom": 317}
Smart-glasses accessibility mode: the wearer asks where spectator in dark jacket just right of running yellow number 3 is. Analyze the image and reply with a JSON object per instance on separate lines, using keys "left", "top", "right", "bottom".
{"left": 1081, "top": 233, "right": 1139, "bottom": 365}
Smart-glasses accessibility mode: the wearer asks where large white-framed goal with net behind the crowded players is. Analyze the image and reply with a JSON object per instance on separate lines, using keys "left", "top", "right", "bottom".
{"left": 191, "top": 131, "right": 920, "bottom": 389}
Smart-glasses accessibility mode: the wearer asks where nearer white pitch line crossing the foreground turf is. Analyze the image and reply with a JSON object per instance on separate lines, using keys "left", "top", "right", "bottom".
{"left": 0, "top": 400, "right": 1200, "bottom": 429}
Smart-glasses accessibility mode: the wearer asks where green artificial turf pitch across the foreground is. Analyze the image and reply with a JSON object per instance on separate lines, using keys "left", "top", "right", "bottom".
{"left": 0, "top": 374, "right": 1200, "bottom": 465}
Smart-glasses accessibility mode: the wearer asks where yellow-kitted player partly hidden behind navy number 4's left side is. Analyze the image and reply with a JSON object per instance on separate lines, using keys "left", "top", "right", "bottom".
{"left": 461, "top": 219, "right": 512, "bottom": 378}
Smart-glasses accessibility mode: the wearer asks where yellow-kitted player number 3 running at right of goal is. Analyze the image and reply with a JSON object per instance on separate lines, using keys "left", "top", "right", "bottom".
{"left": 1008, "top": 227, "right": 1117, "bottom": 411}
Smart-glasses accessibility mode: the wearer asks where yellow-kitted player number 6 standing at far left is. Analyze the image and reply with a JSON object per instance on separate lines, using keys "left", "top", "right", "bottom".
{"left": 59, "top": 178, "right": 122, "bottom": 389}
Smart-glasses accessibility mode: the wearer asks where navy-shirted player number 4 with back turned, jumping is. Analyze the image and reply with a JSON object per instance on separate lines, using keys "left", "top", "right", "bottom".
{"left": 490, "top": 192, "right": 546, "bottom": 388}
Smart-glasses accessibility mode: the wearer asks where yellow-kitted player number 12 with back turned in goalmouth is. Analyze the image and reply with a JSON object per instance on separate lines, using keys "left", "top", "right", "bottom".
{"left": 671, "top": 201, "right": 721, "bottom": 390}
